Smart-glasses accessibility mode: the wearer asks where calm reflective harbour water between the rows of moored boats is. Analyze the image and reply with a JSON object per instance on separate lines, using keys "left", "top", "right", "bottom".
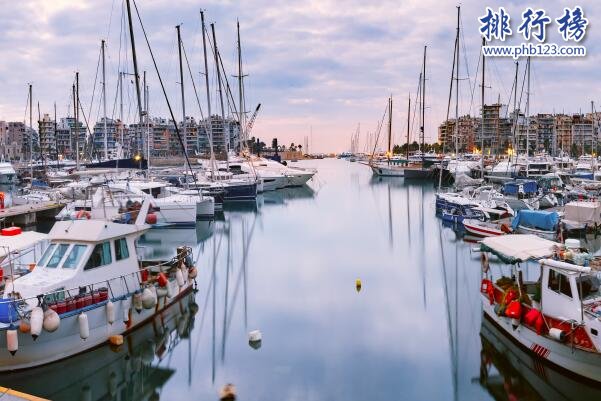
{"left": 8, "top": 160, "right": 592, "bottom": 401}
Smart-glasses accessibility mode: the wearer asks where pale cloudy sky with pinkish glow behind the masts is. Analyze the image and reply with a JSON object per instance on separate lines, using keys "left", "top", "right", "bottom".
{"left": 0, "top": 0, "right": 601, "bottom": 152}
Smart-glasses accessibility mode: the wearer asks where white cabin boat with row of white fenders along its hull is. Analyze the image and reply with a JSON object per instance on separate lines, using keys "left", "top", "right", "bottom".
{"left": 0, "top": 200, "right": 196, "bottom": 371}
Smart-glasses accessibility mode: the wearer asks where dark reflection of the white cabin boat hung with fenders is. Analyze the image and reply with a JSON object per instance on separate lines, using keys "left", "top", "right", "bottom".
{"left": 0, "top": 293, "right": 198, "bottom": 401}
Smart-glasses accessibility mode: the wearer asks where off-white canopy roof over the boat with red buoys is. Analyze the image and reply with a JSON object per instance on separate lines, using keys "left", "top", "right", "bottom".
{"left": 480, "top": 234, "right": 561, "bottom": 264}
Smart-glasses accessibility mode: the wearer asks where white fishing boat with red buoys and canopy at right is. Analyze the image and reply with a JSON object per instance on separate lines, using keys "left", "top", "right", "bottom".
{"left": 480, "top": 234, "right": 601, "bottom": 383}
